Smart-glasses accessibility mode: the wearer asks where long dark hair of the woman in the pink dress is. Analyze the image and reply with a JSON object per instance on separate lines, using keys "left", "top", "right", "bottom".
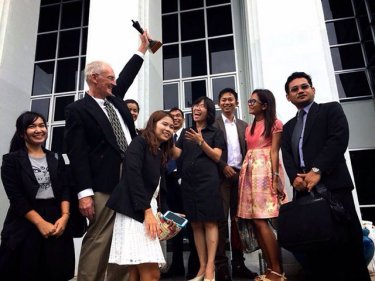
{"left": 250, "top": 89, "right": 276, "bottom": 138}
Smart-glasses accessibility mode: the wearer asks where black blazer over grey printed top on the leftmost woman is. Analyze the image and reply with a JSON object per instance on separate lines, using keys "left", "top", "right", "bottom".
{"left": 1, "top": 149, "right": 69, "bottom": 247}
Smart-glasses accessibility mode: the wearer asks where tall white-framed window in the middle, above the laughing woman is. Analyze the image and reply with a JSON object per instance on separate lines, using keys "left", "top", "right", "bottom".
{"left": 162, "top": 0, "right": 237, "bottom": 126}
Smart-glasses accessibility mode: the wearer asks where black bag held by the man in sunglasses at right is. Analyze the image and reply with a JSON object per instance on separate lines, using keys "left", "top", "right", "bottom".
{"left": 277, "top": 184, "right": 348, "bottom": 252}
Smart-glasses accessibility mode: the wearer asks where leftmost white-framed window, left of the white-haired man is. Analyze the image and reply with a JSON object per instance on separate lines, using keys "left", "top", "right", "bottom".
{"left": 31, "top": 0, "right": 90, "bottom": 152}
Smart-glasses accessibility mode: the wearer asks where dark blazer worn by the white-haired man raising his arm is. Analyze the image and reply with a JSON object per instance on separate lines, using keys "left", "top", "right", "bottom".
{"left": 64, "top": 55, "right": 143, "bottom": 194}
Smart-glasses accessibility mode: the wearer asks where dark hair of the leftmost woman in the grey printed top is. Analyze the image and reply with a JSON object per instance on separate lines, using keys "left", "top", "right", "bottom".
{"left": 9, "top": 111, "right": 47, "bottom": 152}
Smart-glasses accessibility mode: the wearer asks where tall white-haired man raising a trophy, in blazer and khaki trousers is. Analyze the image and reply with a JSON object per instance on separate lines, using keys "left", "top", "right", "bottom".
{"left": 64, "top": 33, "right": 149, "bottom": 281}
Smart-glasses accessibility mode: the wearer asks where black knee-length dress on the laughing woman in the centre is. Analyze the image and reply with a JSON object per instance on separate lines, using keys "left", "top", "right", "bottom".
{"left": 176, "top": 126, "right": 225, "bottom": 221}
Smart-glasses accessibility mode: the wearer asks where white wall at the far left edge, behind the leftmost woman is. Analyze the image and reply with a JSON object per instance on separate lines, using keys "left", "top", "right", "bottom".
{"left": 0, "top": 0, "right": 40, "bottom": 228}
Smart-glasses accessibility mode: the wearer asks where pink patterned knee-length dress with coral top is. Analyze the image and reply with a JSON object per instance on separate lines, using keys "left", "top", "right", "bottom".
{"left": 237, "top": 119, "right": 286, "bottom": 219}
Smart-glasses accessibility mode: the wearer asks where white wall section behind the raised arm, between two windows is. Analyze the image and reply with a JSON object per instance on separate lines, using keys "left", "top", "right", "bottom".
{"left": 86, "top": 0, "right": 163, "bottom": 127}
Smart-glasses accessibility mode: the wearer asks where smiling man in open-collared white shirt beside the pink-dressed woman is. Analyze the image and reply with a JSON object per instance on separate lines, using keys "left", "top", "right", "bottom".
{"left": 214, "top": 88, "right": 257, "bottom": 281}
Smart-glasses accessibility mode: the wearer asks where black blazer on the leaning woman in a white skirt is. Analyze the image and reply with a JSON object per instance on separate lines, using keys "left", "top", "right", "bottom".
{"left": 107, "top": 136, "right": 167, "bottom": 222}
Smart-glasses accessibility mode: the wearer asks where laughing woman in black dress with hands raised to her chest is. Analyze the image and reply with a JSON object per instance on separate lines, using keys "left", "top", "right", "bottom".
{"left": 173, "top": 97, "right": 225, "bottom": 281}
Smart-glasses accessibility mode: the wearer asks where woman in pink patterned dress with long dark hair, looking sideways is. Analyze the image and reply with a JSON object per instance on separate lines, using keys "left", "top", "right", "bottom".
{"left": 237, "top": 89, "right": 286, "bottom": 281}
